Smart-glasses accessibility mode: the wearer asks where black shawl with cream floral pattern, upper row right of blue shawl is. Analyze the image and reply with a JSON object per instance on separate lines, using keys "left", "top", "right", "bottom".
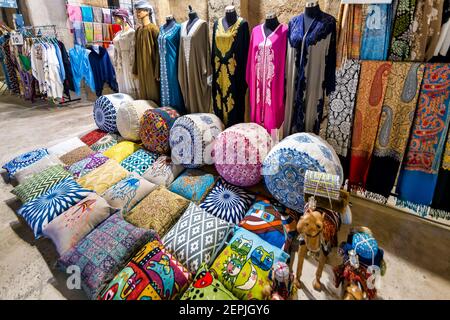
{"left": 389, "top": 0, "right": 417, "bottom": 61}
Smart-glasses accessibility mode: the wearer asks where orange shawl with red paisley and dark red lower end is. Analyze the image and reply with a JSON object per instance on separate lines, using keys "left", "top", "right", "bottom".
{"left": 349, "top": 61, "right": 392, "bottom": 187}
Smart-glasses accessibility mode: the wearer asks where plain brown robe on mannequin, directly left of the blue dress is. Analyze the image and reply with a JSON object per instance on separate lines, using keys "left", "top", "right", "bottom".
{"left": 133, "top": 23, "right": 159, "bottom": 105}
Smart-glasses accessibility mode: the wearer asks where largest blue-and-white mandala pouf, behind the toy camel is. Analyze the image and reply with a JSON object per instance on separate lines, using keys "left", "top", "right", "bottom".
{"left": 263, "top": 133, "right": 344, "bottom": 213}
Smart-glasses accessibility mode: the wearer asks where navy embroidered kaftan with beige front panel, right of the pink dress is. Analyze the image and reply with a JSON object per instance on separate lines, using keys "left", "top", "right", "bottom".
{"left": 289, "top": 12, "right": 336, "bottom": 134}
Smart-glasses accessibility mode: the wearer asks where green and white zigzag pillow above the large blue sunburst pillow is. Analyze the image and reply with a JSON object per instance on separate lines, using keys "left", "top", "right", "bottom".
{"left": 12, "top": 165, "right": 71, "bottom": 203}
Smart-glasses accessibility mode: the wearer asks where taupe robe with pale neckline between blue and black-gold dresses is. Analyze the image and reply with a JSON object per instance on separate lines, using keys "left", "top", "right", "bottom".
{"left": 178, "top": 19, "right": 212, "bottom": 113}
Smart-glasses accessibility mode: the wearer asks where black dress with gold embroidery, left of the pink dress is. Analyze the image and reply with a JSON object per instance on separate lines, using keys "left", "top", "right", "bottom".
{"left": 212, "top": 18, "right": 250, "bottom": 127}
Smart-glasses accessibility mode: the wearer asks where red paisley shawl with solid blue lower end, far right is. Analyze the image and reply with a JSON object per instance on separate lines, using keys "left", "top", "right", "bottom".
{"left": 397, "top": 64, "right": 450, "bottom": 210}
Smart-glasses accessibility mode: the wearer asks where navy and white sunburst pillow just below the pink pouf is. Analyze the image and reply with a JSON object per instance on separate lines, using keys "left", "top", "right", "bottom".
{"left": 200, "top": 179, "right": 255, "bottom": 224}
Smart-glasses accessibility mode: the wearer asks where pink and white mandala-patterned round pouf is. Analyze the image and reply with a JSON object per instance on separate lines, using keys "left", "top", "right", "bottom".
{"left": 214, "top": 123, "right": 273, "bottom": 187}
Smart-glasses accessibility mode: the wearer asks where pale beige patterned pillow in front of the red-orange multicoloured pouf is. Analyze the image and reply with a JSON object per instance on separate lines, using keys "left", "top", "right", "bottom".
{"left": 142, "top": 156, "right": 184, "bottom": 187}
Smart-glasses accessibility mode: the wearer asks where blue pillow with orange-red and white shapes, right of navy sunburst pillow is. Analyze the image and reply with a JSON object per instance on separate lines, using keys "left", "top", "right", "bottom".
{"left": 239, "top": 197, "right": 287, "bottom": 249}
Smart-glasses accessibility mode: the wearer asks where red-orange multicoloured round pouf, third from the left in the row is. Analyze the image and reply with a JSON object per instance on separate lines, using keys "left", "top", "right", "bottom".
{"left": 139, "top": 107, "right": 180, "bottom": 154}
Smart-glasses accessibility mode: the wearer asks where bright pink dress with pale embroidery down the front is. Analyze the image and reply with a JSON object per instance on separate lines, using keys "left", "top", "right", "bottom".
{"left": 246, "top": 24, "right": 288, "bottom": 133}
